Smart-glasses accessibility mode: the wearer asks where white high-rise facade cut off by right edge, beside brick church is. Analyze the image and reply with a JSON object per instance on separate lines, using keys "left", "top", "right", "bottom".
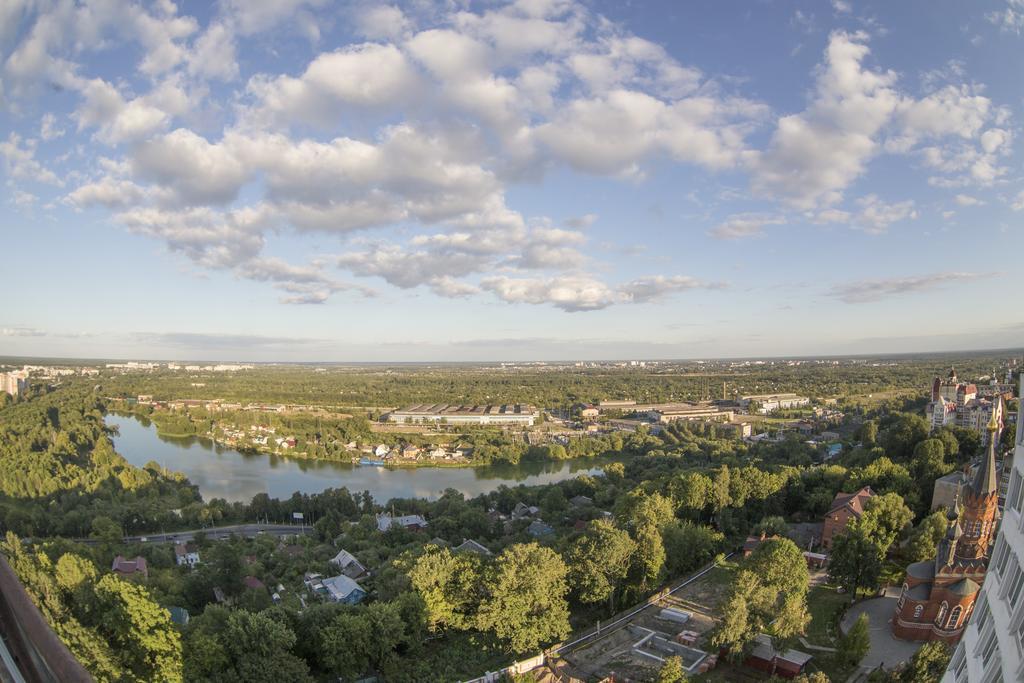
{"left": 942, "top": 382, "right": 1024, "bottom": 683}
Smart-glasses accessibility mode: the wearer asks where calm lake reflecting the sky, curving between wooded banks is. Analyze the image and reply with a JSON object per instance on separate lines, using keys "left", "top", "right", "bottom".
{"left": 106, "top": 414, "right": 622, "bottom": 503}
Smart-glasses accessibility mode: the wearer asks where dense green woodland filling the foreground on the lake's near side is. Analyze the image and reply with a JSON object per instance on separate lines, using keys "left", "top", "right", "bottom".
{"left": 0, "top": 358, "right": 1011, "bottom": 681}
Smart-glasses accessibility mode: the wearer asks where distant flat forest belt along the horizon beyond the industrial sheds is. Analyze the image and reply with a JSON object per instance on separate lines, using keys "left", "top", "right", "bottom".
{"left": 86, "top": 354, "right": 1007, "bottom": 408}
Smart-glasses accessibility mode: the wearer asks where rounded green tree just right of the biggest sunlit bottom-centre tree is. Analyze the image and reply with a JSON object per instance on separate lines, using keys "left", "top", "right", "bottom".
{"left": 565, "top": 520, "right": 636, "bottom": 608}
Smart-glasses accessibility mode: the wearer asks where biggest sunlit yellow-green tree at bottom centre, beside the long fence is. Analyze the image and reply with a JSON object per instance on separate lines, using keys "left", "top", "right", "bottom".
{"left": 477, "top": 543, "right": 569, "bottom": 653}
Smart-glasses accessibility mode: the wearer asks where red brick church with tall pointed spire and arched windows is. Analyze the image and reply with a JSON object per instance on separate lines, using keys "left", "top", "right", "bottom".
{"left": 892, "top": 414, "right": 999, "bottom": 645}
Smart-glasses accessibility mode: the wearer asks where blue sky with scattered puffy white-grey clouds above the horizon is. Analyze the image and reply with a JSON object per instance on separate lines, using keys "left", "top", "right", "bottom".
{"left": 0, "top": 0, "right": 1024, "bottom": 361}
